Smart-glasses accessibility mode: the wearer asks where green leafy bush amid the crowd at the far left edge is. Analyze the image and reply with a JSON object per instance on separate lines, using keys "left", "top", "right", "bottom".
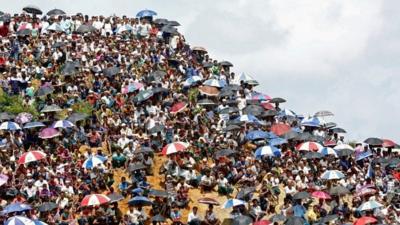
{"left": 0, "top": 88, "right": 39, "bottom": 118}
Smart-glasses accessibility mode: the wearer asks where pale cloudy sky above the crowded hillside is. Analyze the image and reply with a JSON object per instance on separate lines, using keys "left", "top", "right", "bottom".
{"left": 0, "top": 0, "right": 400, "bottom": 143}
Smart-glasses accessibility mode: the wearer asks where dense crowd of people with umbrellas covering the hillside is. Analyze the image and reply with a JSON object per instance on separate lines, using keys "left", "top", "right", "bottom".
{"left": 0, "top": 4, "right": 400, "bottom": 225}
